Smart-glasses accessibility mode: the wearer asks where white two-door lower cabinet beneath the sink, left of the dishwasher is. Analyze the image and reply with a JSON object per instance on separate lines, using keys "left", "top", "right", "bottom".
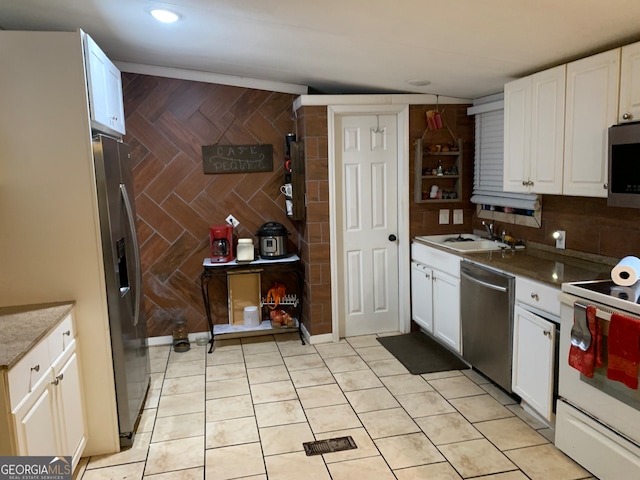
{"left": 411, "top": 242, "right": 461, "bottom": 353}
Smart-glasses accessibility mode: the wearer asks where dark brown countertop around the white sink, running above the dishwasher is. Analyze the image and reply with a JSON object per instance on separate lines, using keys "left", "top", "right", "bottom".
{"left": 414, "top": 239, "right": 617, "bottom": 288}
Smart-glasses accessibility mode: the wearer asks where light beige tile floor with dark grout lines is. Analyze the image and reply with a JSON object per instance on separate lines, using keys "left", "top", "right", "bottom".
{"left": 76, "top": 334, "right": 594, "bottom": 480}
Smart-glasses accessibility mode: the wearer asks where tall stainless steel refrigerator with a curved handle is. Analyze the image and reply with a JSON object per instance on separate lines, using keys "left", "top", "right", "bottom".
{"left": 93, "top": 135, "right": 150, "bottom": 447}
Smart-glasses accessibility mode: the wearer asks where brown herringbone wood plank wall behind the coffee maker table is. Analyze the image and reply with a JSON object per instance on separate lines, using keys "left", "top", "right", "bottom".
{"left": 123, "top": 74, "right": 298, "bottom": 336}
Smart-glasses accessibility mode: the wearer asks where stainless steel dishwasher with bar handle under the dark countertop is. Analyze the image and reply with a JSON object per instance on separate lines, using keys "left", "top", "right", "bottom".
{"left": 460, "top": 260, "right": 515, "bottom": 393}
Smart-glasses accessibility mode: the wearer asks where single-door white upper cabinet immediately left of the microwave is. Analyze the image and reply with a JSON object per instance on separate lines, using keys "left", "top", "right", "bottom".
{"left": 562, "top": 49, "right": 620, "bottom": 197}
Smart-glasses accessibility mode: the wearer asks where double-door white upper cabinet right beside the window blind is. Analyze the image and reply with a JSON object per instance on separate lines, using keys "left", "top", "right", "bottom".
{"left": 503, "top": 65, "right": 566, "bottom": 194}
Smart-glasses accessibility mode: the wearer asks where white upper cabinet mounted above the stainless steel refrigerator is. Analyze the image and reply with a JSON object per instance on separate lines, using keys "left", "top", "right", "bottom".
{"left": 84, "top": 35, "right": 125, "bottom": 135}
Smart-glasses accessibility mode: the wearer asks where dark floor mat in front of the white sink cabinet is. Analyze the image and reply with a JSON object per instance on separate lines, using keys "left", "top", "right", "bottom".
{"left": 378, "top": 332, "right": 469, "bottom": 375}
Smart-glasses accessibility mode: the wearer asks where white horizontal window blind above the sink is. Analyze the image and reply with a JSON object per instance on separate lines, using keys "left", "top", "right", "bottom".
{"left": 467, "top": 99, "right": 539, "bottom": 210}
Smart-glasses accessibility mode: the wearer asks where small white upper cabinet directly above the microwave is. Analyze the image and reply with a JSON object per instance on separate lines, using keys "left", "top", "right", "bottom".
{"left": 618, "top": 42, "right": 640, "bottom": 123}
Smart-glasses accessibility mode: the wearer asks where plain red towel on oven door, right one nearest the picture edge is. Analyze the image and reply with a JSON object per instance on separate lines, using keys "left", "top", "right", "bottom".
{"left": 607, "top": 313, "right": 640, "bottom": 390}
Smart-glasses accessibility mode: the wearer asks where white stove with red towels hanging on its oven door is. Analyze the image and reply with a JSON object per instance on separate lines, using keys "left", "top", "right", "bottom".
{"left": 555, "top": 280, "right": 640, "bottom": 480}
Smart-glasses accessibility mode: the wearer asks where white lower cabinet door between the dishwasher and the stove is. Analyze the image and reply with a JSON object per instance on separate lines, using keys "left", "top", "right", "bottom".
{"left": 512, "top": 305, "right": 556, "bottom": 421}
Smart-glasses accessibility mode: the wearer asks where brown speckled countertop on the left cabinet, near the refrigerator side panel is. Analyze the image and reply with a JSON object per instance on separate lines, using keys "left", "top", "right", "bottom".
{"left": 0, "top": 301, "right": 75, "bottom": 370}
